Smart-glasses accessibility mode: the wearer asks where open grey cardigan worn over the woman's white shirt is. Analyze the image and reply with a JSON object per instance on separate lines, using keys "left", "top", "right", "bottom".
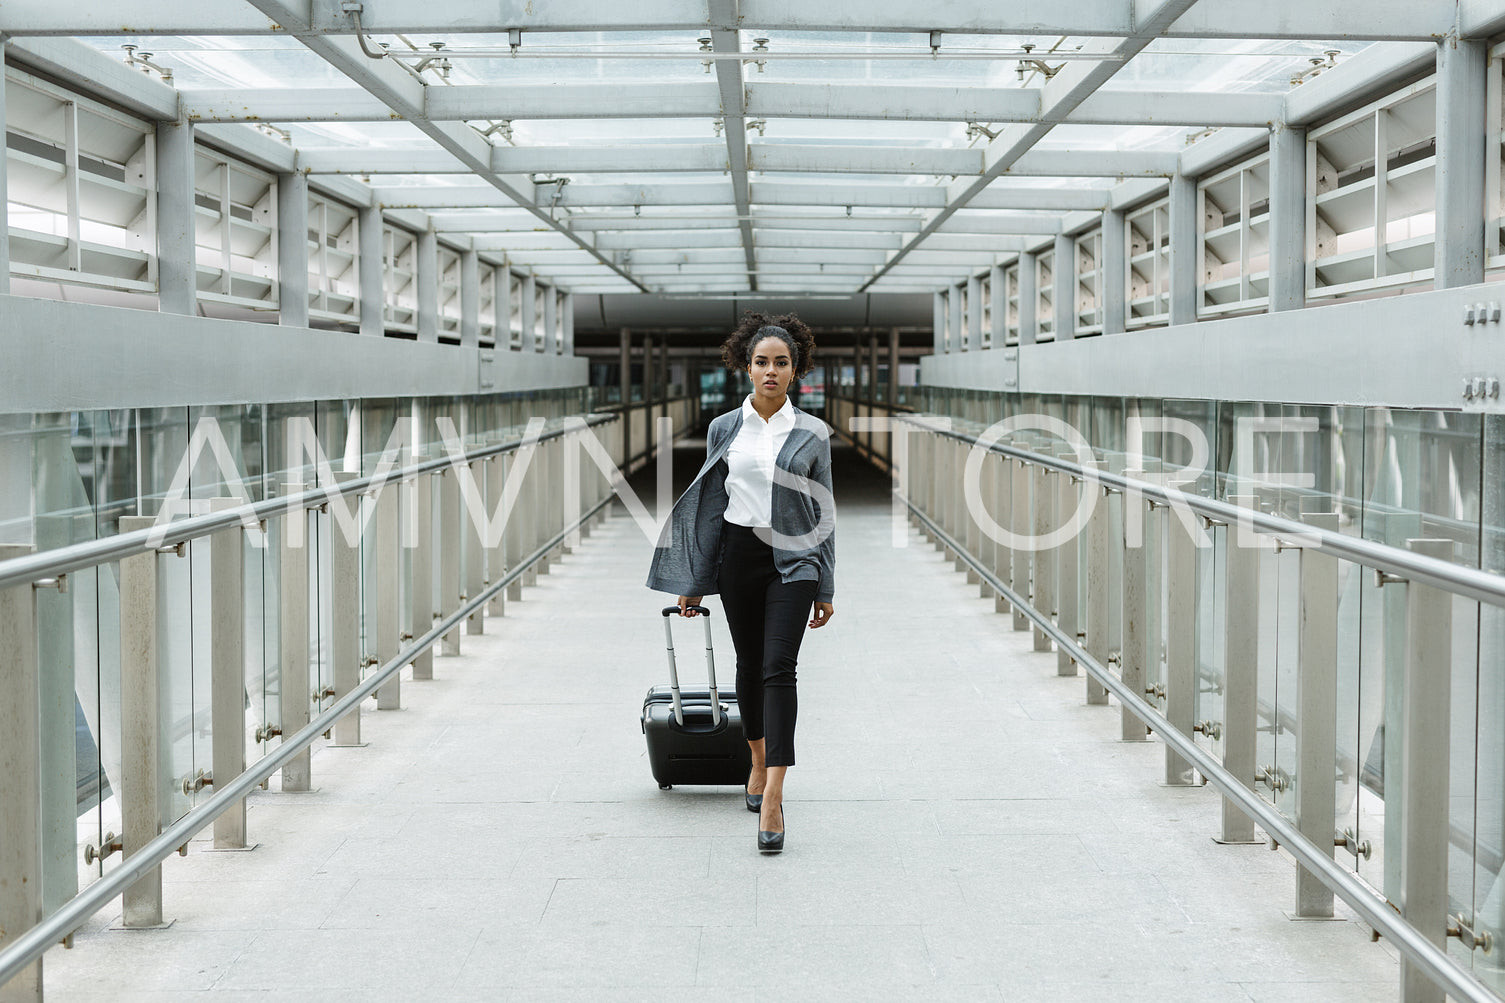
{"left": 647, "top": 407, "right": 837, "bottom": 602}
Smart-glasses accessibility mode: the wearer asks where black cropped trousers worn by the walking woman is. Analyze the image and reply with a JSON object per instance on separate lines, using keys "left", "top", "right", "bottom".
{"left": 718, "top": 523, "right": 817, "bottom": 767}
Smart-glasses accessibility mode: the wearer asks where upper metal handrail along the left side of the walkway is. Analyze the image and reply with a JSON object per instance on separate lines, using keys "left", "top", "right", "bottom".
{"left": 0, "top": 413, "right": 617, "bottom": 589}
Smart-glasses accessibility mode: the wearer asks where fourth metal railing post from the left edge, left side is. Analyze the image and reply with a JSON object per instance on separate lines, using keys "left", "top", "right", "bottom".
{"left": 281, "top": 480, "right": 313, "bottom": 792}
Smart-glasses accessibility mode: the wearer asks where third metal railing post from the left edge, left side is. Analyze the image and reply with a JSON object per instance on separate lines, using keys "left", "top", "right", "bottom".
{"left": 209, "top": 498, "right": 245, "bottom": 849}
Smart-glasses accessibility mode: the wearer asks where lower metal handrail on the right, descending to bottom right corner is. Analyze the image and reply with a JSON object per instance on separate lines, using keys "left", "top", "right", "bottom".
{"left": 905, "top": 498, "right": 1500, "bottom": 1003}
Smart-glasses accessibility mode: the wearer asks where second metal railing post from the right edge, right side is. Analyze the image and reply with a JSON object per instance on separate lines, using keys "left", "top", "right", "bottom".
{"left": 1296, "top": 512, "right": 1342, "bottom": 919}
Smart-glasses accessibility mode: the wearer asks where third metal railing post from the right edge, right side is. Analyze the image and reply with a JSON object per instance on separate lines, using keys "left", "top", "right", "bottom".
{"left": 1218, "top": 494, "right": 1261, "bottom": 843}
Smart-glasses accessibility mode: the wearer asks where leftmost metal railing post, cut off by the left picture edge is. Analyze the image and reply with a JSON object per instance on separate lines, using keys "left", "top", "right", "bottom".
{"left": 0, "top": 545, "right": 42, "bottom": 1003}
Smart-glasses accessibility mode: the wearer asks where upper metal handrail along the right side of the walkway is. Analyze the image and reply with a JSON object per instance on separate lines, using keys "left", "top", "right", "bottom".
{"left": 898, "top": 419, "right": 1505, "bottom": 607}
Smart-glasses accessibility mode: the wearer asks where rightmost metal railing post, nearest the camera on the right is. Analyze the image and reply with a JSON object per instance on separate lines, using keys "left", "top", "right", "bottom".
{"left": 1401, "top": 539, "right": 1452, "bottom": 1003}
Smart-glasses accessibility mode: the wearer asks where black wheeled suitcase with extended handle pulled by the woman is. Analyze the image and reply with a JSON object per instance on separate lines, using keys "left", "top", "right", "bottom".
{"left": 643, "top": 605, "right": 753, "bottom": 791}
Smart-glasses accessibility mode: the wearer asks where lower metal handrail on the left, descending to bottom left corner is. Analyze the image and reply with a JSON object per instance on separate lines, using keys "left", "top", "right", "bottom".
{"left": 0, "top": 482, "right": 616, "bottom": 986}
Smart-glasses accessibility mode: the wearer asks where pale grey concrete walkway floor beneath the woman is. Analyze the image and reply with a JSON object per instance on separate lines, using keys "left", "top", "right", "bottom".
{"left": 45, "top": 447, "right": 1397, "bottom": 1003}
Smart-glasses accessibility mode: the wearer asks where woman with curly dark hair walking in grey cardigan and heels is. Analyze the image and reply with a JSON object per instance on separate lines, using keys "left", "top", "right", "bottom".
{"left": 649, "top": 313, "right": 835, "bottom": 852}
